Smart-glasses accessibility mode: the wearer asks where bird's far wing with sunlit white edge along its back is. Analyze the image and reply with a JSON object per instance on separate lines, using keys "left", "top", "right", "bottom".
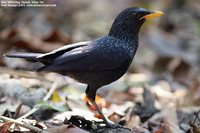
{"left": 37, "top": 41, "right": 91, "bottom": 63}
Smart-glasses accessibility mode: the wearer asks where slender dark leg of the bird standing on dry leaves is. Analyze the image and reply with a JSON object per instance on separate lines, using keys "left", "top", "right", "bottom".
{"left": 86, "top": 86, "right": 111, "bottom": 126}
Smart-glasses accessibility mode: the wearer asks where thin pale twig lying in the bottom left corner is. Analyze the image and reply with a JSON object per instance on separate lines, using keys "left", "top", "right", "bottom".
{"left": 0, "top": 115, "right": 49, "bottom": 133}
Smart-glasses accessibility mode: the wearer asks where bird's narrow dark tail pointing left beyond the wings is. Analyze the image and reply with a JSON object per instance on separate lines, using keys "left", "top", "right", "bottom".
{"left": 4, "top": 52, "right": 42, "bottom": 61}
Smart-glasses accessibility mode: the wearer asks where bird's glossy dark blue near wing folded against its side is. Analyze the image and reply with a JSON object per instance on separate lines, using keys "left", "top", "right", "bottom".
{"left": 40, "top": 42, "right": 129, "bottom": 71}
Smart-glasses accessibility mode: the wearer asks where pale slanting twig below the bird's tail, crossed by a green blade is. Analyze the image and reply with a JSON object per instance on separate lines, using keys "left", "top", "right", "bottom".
{"left": 17, "top": 82, "right": 57, "bottom": 120}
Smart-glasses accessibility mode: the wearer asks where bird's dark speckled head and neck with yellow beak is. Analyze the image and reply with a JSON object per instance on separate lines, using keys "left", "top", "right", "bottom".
{"left": 109, "top": 7, "right": 164, "bottom": 39}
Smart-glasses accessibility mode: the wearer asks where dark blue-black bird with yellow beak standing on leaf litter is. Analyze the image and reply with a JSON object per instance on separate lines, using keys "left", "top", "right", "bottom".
{"left": 6, "top": 8, "right": 163, "bottom": 125}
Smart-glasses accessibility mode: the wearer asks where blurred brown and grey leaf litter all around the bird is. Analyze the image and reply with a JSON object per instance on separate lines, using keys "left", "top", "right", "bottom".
{"left": 0, "top": 0, "right": 200, "bottom": 133}
